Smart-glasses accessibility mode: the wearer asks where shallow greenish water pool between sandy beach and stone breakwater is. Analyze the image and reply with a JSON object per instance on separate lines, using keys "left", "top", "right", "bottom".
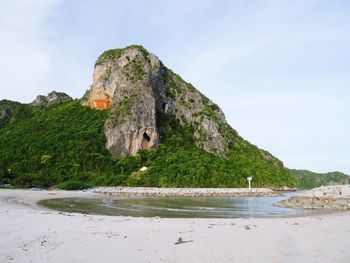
{"left": 39, "top": 193, "right": 308, "bottom": 218}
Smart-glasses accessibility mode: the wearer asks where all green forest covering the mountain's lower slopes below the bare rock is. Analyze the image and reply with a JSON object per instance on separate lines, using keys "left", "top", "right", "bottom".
{"left": 0, "top": 101, "right": 295, "bottom": 189}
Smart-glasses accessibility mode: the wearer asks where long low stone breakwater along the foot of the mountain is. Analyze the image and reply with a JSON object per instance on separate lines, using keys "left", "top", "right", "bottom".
{"left": 86, "top": 187, "right": 277, "bottom": 197}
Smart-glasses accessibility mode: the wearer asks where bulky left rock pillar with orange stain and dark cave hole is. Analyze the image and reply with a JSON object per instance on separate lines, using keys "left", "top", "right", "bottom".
{"left": 83, "top": 47, "right": 159, "bottom": 156}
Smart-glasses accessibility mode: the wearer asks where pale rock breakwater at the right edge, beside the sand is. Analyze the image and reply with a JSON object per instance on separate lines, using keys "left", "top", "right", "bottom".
{"left": 277, "top": 185, "right": 350, "bottom": 210}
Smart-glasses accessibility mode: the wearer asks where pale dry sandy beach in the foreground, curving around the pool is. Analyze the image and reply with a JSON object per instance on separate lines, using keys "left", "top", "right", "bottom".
{"left": 0, "top": 190, "right": 350, "bottom": 263}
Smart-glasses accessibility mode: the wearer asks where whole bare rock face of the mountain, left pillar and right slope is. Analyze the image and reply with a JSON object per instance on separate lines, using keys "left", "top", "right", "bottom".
{"left": 82, "top": 46, "right": 277, "bottom": 164}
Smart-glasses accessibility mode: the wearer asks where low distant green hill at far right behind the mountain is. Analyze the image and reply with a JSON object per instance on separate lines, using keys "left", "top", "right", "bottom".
{"left": 289, "top": 169, "right": 350, "bottom": 189}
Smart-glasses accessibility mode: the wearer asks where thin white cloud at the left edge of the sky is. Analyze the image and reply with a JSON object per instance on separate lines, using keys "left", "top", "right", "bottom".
{"left": 0, "top": 0, "right": 59, "bottom": 101}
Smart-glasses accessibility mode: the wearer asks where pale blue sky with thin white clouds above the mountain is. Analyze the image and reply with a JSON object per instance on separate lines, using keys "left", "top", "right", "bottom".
{"left": 0, "top": 0, "right": 350, "bottom": 174}
